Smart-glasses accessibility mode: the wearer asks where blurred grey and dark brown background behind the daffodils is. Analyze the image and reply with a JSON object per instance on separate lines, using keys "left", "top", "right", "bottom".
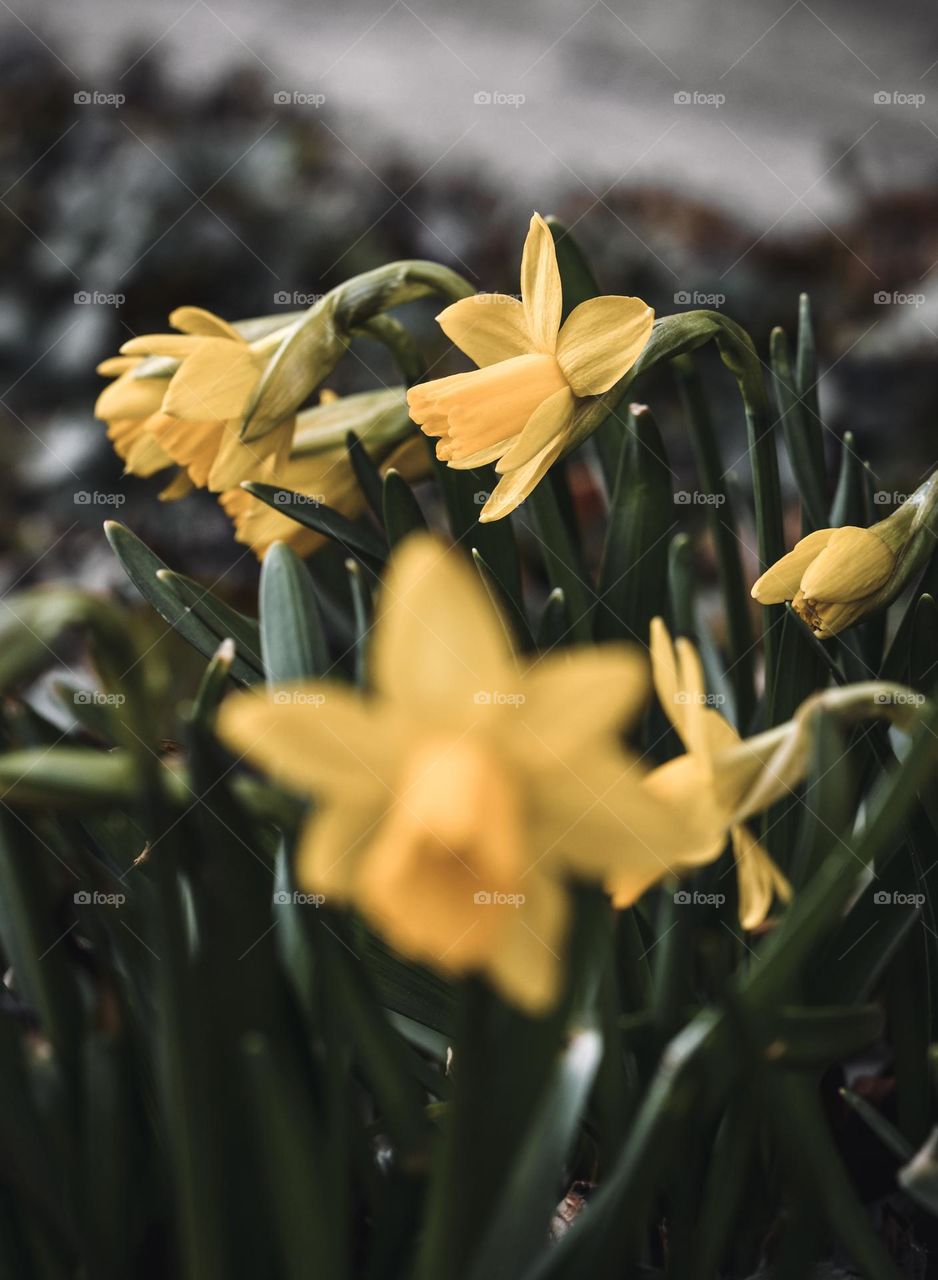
{"left": 0, "top": 0, "right": 938, "bottom": 591}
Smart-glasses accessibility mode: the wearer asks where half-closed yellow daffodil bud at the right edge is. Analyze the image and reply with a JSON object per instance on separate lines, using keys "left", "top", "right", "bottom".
{"left": 752, "top": 476, "right": 938, "bottom": 640}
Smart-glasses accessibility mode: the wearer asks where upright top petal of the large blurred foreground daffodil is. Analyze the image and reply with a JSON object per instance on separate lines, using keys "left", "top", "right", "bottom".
{"left": 371, "top": 535, "right": 517, "bottom": 723}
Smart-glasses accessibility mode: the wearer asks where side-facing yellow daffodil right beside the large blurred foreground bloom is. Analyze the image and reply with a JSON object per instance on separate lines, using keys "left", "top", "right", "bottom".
{"left": 613, "top": 618, "right": 791, "bottom": 929}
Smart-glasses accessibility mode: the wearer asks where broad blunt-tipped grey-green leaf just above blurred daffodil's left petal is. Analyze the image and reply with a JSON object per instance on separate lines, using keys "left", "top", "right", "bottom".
{"left": 260, "top": 543, "right": 329, "bottom": 685}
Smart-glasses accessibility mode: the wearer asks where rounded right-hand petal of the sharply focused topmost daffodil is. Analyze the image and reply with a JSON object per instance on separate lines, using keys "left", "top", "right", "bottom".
{"left": 557, "top": 297, "right": 655, "bottom": 396}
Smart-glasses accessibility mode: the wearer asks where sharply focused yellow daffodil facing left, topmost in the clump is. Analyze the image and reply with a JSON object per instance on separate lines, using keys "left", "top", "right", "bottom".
{"left": 407, "top": 214, "right": 654, "bottom": 521}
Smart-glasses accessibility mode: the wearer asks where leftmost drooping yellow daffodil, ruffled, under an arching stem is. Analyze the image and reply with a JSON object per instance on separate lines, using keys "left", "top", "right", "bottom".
{"left": 108, "top": 307, "right": 316, "bottom": 492}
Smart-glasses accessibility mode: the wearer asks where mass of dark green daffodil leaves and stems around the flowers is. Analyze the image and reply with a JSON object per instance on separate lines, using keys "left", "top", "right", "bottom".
{"left": 0, "top": 220, "right": 938, "bottom": 1280}
